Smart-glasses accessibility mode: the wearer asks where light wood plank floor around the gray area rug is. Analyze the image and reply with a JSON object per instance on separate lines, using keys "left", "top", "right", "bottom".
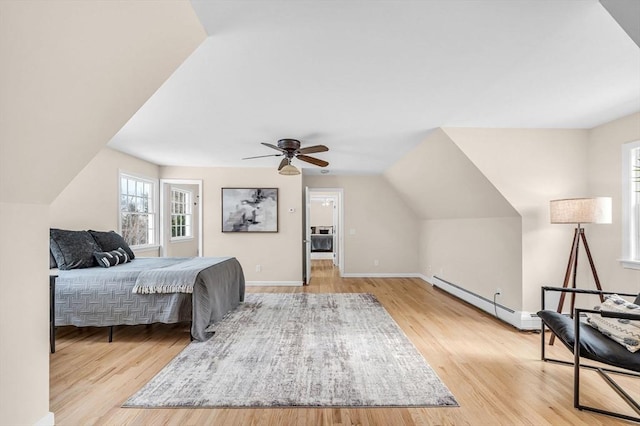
{"left": 50, "top": 260, "right": 640, "bottom": 425}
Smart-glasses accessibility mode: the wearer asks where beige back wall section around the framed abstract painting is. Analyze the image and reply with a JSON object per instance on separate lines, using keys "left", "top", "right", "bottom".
{"left": 160, "top": 167, "right": 303, "bottom": 285}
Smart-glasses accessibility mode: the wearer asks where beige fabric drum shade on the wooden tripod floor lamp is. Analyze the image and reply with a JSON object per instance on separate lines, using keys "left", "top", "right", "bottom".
{"left": 550, "top": 197, "right": 611, "bottom": 223}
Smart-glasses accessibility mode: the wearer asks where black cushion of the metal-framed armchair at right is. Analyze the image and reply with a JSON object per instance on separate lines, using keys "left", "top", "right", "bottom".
{"left": 538, "top": 310, "right": 640, "bottom": 372}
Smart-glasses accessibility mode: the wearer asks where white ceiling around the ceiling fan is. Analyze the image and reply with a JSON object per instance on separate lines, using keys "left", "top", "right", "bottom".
{"left": 109, "top": 0, "right": 640, "bottom": 174}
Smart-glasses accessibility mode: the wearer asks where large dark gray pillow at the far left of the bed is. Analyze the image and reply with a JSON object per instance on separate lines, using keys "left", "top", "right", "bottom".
{"left": 49, "top": 228, "right": 102, "bottom": 270}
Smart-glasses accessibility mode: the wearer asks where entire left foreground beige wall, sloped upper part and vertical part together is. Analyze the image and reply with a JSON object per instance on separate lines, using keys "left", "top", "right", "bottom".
{"left": 0, "top": 0, "right": 206, "bottom": 425}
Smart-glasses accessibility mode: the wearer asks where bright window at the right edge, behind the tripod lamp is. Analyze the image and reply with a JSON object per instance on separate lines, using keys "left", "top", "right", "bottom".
{"left": 622, "top": 141, "right": 640, "bottom": 269}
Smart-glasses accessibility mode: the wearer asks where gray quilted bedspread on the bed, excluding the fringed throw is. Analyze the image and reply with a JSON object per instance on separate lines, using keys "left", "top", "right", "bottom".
{"left": 55, "top": 258, "right": 245, "bottom": 341}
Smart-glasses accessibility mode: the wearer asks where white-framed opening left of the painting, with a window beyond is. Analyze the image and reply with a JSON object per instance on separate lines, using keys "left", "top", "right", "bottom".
{"left": 160, "top": 179, "right": 203, "bottom": 257}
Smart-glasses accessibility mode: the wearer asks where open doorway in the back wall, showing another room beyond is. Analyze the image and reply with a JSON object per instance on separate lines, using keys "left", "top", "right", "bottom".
{"left": 304, "top": 188, "right": 344, "bottom": 284}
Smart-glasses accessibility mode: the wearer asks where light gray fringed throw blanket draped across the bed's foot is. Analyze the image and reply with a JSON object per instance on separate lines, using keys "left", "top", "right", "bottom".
{"left": 132, "top": 257, "right": 230, "bottom": 294}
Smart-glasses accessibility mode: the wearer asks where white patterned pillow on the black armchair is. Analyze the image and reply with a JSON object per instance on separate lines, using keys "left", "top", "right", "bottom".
{"left": 587, "top": 294, "right": 640, "bottom": 352}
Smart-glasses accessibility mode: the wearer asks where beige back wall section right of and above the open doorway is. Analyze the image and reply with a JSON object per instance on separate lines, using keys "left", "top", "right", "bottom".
{"left": 303, "top": 175, "right": 419, "bottom": 275}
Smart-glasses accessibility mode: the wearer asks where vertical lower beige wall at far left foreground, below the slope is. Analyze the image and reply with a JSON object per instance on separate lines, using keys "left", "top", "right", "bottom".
{"left": 0, "top": 202, "right": 49, "bottom": 425}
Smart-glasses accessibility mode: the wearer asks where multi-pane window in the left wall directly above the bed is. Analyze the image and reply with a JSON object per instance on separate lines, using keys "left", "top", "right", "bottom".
{"left": 120, "top": 173, "right": 157, "bottom": 247}
